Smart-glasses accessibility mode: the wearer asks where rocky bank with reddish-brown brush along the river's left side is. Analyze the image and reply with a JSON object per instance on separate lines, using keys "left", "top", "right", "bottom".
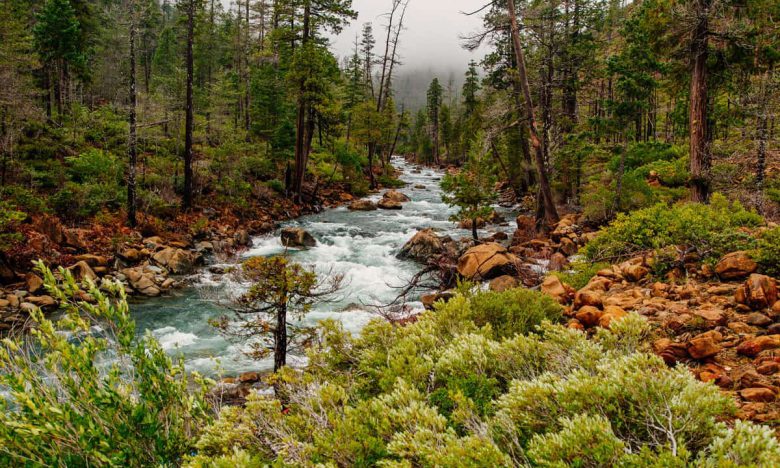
{"left": 0, "top": 183, "right": 362, "bottom": 332}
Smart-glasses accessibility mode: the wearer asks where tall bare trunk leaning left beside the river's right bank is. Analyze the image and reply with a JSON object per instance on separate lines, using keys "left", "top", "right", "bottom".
{"left": 507, "top": 0, "right": 560, "bottom": 228}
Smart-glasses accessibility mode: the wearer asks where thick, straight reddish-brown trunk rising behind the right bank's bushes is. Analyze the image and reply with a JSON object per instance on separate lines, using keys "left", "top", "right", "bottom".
{"left": 688, "top": 0, "right": 712, "bottom": 203}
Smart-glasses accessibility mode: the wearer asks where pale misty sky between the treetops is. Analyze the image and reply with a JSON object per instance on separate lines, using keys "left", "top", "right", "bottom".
{"left": 333, "top": 0, "right": 483, "bottom": 71}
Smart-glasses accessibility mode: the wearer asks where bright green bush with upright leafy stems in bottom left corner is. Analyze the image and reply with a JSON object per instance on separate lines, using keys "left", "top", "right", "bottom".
{"left": 0, "top": 264, "right": 210, "bottom": 466}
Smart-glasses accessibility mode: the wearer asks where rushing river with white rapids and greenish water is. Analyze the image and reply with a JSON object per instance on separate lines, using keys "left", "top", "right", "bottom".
{"left": 131, "top": 158, "right": 511, "bottom": 376}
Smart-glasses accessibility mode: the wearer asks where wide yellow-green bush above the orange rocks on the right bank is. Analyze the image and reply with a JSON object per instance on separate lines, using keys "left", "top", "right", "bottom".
{"left": 582, "top": 194, "right": 763, "bottom": 261}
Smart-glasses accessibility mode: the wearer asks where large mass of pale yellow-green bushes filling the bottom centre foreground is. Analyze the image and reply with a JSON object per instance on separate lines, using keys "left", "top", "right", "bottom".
{"left": 188, "top": 293, "right": 780, "bottom": 467}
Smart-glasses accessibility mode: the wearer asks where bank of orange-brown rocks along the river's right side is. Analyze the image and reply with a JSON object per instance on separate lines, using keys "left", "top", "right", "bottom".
{"left": 401, "top": 210, "right": 780, "bottom": 430}
